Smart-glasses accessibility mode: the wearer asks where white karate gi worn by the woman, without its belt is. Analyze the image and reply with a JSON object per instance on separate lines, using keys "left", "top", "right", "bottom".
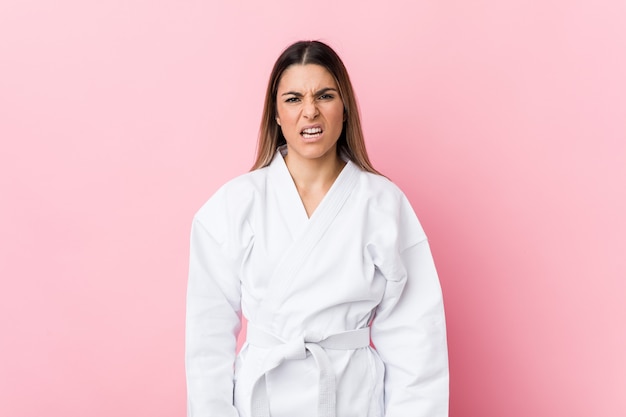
{"left": 186, "top": 152, "right": 448, "bottom": 417}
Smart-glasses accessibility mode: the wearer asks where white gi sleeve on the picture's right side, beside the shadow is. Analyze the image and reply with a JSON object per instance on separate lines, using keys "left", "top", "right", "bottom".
{"left": 371, "top": 196, "right": 449, "bottom": 417}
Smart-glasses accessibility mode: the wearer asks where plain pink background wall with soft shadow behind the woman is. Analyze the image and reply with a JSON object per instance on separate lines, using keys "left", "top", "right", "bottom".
{"left": 0, "top": 0, "right": 626, "bottom": 417}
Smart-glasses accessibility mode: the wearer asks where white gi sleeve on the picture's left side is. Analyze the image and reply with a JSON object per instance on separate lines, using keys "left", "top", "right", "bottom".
{"left": 185, "top": 213, "right": 241, "bottom": 417}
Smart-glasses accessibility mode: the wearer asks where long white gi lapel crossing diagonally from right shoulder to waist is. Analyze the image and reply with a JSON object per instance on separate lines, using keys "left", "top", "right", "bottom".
{"left": 258, "top": 151, "right": 360, "bottom": 320}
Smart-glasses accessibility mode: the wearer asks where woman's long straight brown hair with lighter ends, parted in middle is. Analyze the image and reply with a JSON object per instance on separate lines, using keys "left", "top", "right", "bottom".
{"left": 252, "top": 41, "right": 380, "bottom": 174}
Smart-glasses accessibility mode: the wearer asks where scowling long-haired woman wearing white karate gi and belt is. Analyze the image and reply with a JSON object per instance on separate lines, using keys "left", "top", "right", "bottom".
{"left": 186, "top": 41, "right": 448, "bottom": 417}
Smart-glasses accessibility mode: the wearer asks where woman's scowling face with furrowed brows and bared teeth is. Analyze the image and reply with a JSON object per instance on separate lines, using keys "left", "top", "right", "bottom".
{"left": 276, "top": 64, "right": 344, "bottom": 161}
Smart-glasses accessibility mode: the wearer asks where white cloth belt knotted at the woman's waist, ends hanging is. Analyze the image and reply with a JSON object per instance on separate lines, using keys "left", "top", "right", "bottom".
{"left": 247, "top": 323, "right": 370, "bottom": 417}
